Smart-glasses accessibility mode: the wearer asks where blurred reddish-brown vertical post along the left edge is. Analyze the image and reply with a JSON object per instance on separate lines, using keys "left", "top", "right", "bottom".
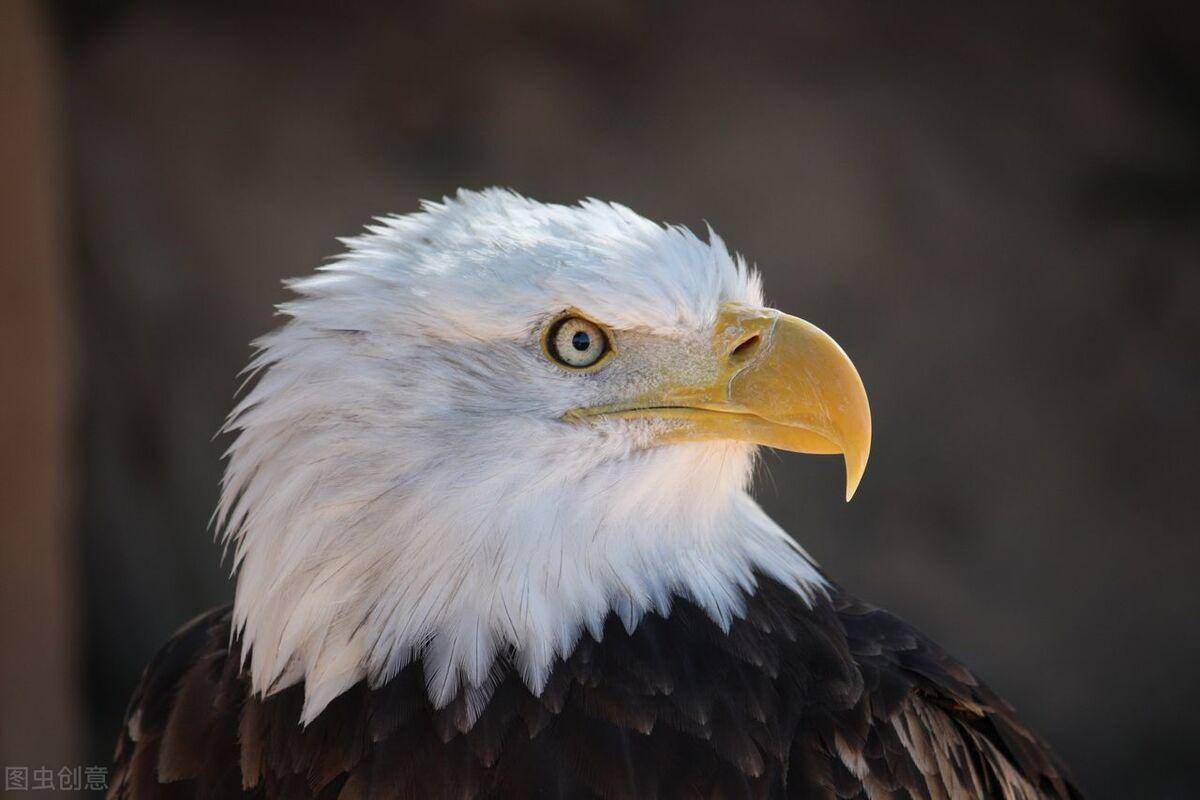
{"left": 0, "top": 0, "right": 80, "bottom": 771}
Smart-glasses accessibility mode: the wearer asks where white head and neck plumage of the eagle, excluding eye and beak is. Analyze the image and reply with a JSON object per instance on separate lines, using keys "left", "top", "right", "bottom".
{"left": 218, "top": 190, "right": 822, "bottom": 722}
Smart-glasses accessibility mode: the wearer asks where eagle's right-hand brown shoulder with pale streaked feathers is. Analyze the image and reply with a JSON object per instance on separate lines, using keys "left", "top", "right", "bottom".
{"left": 821, "top": 588, "right": 1082, "bottom": 800}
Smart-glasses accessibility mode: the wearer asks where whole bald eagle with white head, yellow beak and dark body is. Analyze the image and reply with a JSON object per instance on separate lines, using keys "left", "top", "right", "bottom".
{"left": 112, "top": 191, "right": 1079, "bottom": 800}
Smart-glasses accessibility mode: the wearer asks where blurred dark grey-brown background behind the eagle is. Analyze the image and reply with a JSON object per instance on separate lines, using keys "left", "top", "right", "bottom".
{"left": 0, "top": 0, "right": 1200, "bottom": 798}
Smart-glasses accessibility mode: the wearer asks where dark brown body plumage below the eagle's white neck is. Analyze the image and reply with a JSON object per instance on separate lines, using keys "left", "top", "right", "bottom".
{"left": 110, "top": 578, "right": 1080, "bottom": 800}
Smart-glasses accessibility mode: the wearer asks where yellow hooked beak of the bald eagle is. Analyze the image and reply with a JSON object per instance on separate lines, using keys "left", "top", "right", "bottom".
{"left": 566, "top": 303, "right": 871, "bottom": 500}
